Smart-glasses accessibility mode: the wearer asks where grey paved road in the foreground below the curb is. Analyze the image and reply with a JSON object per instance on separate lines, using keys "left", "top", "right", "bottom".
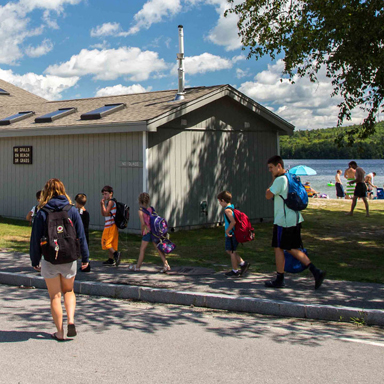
{"left": 0, "top": 285, "right": 384, "bottom": 384}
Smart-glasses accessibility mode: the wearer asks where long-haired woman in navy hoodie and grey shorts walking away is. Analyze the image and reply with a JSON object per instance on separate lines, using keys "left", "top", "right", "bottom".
{"left": 30, "top": 179, "right": 89, "bottom": 341}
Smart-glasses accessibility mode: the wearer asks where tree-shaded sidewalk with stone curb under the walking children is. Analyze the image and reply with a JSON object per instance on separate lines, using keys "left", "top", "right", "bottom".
{"left": 0, "top": 252, "right": 384, "bottom": 325}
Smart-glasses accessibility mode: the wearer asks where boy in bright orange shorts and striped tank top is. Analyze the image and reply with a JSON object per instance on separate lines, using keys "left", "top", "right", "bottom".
{"left": 100, "top": 185, "right": 121, "bottom": 267}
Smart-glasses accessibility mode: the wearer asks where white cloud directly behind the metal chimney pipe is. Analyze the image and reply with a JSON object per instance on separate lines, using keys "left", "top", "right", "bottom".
{"left": 171, "top": 52, "right": 233, "bottom": 75}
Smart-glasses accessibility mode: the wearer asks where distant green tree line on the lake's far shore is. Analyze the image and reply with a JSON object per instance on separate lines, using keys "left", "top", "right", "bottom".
{"left": 280, "top": 122, "right": 384, "bottom": 159}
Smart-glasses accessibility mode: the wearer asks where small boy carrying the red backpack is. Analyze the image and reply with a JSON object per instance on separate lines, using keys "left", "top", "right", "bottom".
{"left": 217, "top": 191, "right": 253, "bottom": 277}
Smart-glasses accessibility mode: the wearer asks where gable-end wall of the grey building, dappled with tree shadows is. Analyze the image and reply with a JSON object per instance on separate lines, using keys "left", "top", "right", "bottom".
{"left": 148, "top": 99, "right": 278, "bottom": 227}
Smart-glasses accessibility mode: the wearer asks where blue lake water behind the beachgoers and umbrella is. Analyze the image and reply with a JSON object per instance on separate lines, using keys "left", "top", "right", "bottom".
{"left": 284, "top": 159, "right": 384, "bottom": 199}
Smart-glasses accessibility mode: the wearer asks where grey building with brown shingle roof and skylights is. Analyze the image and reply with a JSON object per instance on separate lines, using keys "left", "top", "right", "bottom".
{"left": 0, "top": 80, "right": 294, "bottom": 232}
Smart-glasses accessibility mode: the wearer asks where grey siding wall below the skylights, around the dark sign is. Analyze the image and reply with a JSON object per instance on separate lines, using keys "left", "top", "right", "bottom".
{"left": 0, "top": 132, "right": 143, "bottom": 230}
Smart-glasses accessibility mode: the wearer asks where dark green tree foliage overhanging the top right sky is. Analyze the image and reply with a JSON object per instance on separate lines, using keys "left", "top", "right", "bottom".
{"left": 226, "top": 0, "right": 384, "bottom": 145}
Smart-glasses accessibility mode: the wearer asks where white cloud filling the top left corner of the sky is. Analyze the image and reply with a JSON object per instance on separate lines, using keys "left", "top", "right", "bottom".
{"left": 0, "top": 0, "right": 82, "bottom": 65}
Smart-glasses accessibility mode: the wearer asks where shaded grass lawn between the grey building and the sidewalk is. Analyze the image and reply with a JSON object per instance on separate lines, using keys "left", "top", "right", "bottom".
{"left": 0, "top": 199, "right": 384, "bottom": 284}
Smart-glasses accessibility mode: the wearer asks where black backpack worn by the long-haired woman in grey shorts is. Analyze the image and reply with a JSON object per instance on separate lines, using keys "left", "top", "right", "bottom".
{"left": 40, "top": 204, "right": 80, "bottom": 264}
